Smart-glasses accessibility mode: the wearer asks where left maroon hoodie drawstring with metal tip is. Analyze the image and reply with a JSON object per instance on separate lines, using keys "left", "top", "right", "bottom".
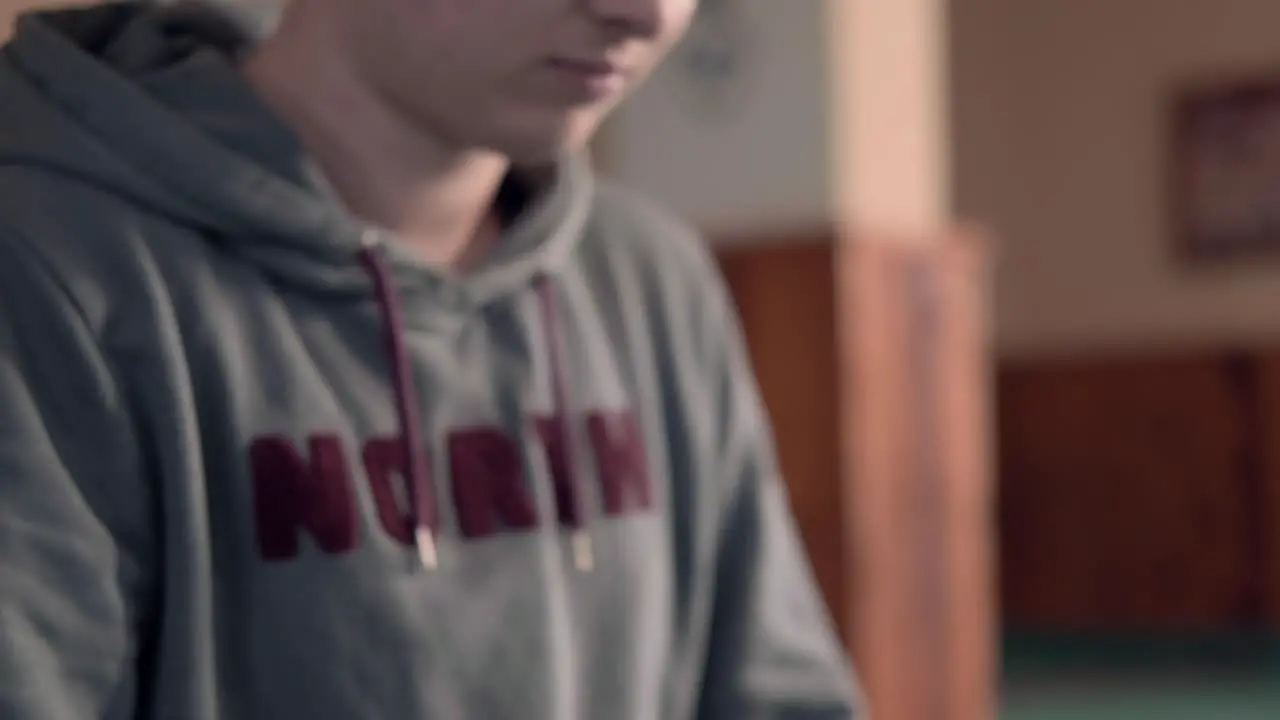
{"left": 360, "top": 233, "right": 439, "bottom": 570}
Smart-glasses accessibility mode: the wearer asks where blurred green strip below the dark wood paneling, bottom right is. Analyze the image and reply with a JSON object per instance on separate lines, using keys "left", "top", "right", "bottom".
{"left": 1001, "top": 634, "right": 1280, "bottom": 720}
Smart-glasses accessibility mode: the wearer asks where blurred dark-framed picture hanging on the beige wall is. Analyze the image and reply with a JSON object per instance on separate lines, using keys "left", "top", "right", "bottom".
{"left": 1171, "top": 72, "right": 1280, "bottom": 263}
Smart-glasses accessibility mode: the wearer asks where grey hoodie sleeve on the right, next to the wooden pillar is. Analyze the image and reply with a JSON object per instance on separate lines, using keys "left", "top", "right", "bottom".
{"left": 699, "top": 269, "right": 863, "bottom": 720}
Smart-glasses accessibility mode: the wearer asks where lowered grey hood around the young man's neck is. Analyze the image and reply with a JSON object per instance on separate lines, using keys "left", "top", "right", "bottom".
{"left": 0, "top": 3, "right": 593, "bottom": 306}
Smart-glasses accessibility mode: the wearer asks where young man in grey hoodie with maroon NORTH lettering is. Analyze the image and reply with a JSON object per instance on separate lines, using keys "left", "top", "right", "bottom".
{"left": 0, "top": 0, "right": 856, "bottom": 720}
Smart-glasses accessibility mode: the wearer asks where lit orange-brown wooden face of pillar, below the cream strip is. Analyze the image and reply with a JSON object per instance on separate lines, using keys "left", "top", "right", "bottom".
{"left": 837, "top": 229, "right": 997, "bottom": 720}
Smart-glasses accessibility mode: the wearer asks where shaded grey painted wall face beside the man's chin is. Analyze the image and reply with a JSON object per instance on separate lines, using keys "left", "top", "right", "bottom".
{"left": 605, "top": 0, "right": 835, "bottom": 237}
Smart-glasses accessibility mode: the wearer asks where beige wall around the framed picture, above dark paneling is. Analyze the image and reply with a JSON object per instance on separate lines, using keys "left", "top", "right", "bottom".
{"left": 954, "top": 0, "right": 1280, "bottom": 354}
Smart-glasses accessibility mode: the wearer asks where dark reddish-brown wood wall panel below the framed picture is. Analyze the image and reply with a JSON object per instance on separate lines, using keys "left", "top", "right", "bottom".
{"left": 998, "top": 354, "right": 1258, "bottom": 632}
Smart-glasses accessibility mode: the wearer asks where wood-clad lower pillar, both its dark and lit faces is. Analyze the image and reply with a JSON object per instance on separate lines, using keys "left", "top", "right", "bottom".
{"left": 721, "top": 224, "right": 997, "bottom": 720}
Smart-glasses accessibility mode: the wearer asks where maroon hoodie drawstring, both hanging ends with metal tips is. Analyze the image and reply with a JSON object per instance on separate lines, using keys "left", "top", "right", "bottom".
{"left": 360, "top": 232, "right": 595, "bottom": 571}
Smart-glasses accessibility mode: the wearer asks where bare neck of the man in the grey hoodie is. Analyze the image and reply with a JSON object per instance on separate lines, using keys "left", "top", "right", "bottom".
{"left": 243, "top": 16, "right": 508, "bottom": 269}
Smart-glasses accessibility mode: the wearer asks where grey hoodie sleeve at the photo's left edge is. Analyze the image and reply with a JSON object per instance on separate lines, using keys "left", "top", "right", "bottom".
{"left": 0, "top": 228, "right": 146, "bottom": 720}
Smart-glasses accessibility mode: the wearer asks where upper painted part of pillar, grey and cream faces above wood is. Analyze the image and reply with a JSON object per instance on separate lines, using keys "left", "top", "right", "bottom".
{"left": 603, "top": 0, "right": 951, "bottom": 238}
